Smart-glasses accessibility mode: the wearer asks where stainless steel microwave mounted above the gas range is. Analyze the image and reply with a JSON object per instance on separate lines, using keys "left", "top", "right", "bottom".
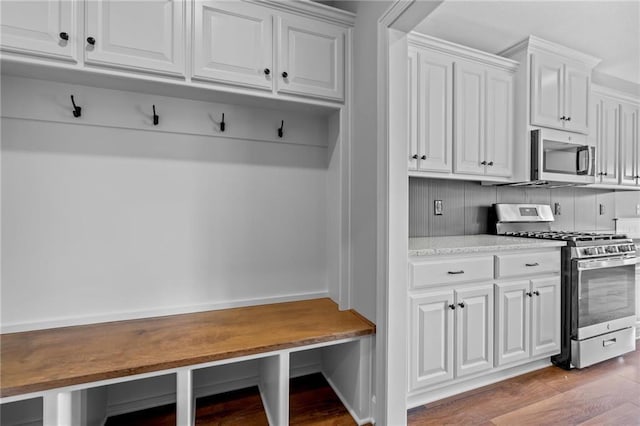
{"left": 531, "top": 129, "right": 596, "bottom": 185}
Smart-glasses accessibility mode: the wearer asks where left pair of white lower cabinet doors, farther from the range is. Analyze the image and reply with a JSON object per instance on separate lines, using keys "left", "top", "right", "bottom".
{"left": 410, "top": 284, "right": 493, "bottom": 390}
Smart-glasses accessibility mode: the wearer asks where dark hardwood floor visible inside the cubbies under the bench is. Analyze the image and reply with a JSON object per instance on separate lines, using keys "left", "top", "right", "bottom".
{"left": 105, "top": 373, "right": 356, "bottom": 426}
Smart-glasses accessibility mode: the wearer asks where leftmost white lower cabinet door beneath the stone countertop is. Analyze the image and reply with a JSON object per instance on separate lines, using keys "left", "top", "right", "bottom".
{"left": 409, "top": 291, "right": 455, "bottom": 390}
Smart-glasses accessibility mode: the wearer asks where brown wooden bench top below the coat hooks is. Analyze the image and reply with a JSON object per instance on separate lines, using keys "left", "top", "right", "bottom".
{"left": 0, "top": 299, "right": 375, "bottom": 397}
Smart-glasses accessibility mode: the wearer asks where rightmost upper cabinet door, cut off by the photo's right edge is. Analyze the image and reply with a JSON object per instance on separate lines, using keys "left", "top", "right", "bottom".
{"left": 620, "top": 103, "right": 640, "bottom": 186}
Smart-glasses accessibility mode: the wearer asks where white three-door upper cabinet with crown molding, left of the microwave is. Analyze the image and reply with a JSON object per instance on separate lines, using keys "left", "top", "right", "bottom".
{"left": 409, "top": 34, "right": 518, "bottom": 182}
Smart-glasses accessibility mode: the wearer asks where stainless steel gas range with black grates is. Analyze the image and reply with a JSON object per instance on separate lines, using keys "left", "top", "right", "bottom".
{"left": 494, "top": 204, "right": 636, "bottom": 369}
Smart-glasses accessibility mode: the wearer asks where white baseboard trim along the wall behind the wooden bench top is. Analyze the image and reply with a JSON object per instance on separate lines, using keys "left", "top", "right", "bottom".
{"left": 0, "top": 291, "right": 330, "bottom": 334}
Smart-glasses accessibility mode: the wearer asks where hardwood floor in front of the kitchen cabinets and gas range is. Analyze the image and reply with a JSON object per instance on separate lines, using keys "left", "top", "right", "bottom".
{"left": 408, "top": 349, "right": 640, "bottom": 426}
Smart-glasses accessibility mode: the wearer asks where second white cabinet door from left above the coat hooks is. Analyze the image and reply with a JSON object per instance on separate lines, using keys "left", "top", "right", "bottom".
{"left": 83, "top": 0, "right": 186, "bottom": 76}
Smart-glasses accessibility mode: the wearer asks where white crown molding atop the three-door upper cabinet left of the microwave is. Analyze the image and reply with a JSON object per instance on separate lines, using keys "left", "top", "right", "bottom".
{"left": 409, "top": 32, "right": 520, "bottom": 72}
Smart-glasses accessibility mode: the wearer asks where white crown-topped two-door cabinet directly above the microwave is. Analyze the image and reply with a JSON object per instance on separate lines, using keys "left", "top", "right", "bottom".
{"left": 500, "top": 36, "right": 600, "bottom": 134}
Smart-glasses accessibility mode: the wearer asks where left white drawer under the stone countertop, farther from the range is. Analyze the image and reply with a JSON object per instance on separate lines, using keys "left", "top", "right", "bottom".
{"left": 409, "top": 256, "right": 493, "bottom": 288}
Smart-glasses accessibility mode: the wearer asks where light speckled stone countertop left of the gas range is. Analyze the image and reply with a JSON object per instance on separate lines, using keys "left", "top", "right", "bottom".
{"left": 409, "top": 234, "right": 566, "bottom": 256}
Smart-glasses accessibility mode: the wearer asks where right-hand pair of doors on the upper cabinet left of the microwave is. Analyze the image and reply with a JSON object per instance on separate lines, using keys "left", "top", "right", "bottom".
{"left": 454, "top": 61, "right": 513, "bottom": 177}
